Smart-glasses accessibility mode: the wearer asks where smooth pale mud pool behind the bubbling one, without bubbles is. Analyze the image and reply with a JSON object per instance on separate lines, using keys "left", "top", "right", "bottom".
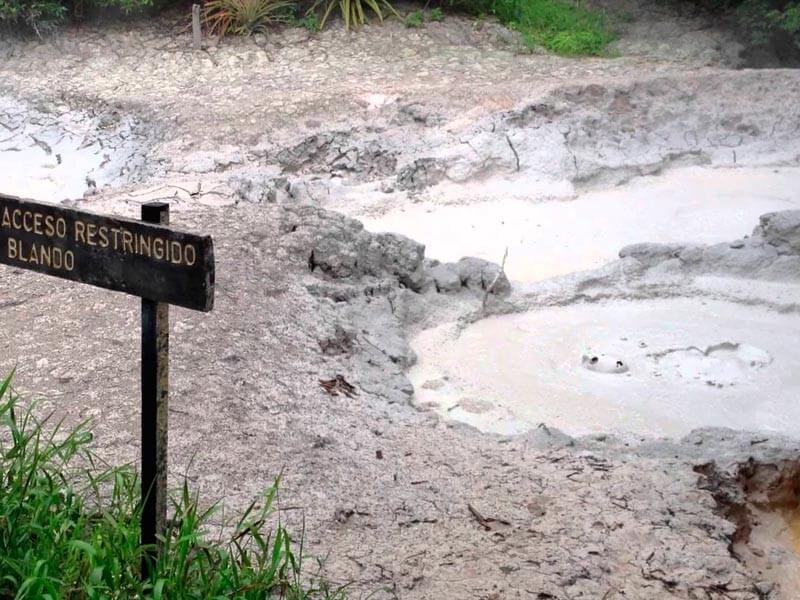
{"left": 362, "top": 167, "right": 800, "bottom": 282}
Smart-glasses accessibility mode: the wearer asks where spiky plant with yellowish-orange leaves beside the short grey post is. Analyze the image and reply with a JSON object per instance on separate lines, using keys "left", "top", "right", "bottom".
{"left": 203, "top": 0, "right": 294, "bottom": 37}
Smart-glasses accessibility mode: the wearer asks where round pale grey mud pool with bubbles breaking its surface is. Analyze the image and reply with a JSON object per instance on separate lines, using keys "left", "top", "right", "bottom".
{"left": 410, "top": 299, "right": 800, "bottom": 437}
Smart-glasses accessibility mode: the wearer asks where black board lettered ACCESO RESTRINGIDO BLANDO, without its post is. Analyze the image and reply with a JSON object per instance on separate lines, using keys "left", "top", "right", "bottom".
{"left": 0, "top": 194, "right": 214, "bottom": 311}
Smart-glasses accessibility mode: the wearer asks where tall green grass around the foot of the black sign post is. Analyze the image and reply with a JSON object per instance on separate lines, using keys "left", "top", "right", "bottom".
{"left": 0, "top": 377, "right": 345, "bottom": 600}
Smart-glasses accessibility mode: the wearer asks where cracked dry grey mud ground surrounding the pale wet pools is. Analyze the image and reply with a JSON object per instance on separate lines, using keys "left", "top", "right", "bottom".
{"left": 0, "top": 5, "right": 800, "bottom": 600}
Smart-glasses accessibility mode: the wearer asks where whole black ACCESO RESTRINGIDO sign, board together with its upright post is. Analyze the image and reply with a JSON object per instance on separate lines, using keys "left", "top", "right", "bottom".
{"left": 0, "top": 194, "right": 214, "bottom": 579}
